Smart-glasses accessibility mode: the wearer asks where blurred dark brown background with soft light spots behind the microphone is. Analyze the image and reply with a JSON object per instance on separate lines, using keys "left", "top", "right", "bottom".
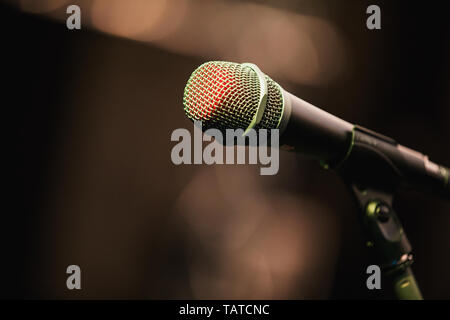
{"left": 4, "top": 0, "right": 450, "bottom": 299}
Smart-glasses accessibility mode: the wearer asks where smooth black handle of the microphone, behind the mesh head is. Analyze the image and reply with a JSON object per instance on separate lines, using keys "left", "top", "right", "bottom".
{"left": 280, "top": 90, "right": 450, "bottom": 200}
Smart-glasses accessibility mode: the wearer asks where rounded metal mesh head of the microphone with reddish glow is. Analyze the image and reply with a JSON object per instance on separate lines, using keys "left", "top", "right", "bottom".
{"left": 183, "top": 61, "right": 283, "bottom": 131}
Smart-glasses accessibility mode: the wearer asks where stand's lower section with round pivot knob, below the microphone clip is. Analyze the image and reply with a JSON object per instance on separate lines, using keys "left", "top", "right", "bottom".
{"left": 347, "top": 182, "right": 423, "bottom": 300}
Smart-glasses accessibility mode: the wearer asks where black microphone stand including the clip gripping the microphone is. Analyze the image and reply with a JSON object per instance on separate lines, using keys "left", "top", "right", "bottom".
{"left": 333, "top": 126, "right": 423, "bottom": 300}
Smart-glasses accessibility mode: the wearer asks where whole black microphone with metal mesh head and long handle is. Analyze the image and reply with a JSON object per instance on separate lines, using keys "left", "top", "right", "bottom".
{"left": 183, "top": 61, "right": 450, "bottom": 199}
